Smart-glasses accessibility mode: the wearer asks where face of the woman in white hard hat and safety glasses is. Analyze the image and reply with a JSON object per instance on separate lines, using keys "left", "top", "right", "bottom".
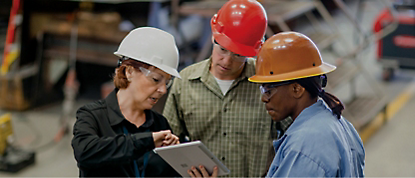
{"left": 126, "top": 67, "right": 171, "bottom": 110}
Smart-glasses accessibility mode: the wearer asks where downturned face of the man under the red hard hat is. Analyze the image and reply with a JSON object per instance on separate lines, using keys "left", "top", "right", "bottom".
{"left": 210, "top": 42, "right": 246, "bottom": 80}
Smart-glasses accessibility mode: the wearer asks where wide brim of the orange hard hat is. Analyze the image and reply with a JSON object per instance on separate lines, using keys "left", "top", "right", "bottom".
{"left": 248, "top": 62, "right": 336, "bottom": 83}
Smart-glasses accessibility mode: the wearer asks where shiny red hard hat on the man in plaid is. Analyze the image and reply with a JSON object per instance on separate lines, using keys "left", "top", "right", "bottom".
{"left": 210, "top": 0, "right": 267, "bottom": 57}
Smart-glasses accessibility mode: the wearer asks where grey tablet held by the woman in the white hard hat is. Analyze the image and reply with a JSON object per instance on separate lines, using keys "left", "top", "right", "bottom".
{"left": 153, "top": 141, "right": 230, "bottom": 177}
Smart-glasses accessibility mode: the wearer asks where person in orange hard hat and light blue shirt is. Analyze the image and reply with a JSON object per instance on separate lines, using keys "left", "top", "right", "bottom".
{"left": 249, "top": 32, "right": 365, "bottom": 177}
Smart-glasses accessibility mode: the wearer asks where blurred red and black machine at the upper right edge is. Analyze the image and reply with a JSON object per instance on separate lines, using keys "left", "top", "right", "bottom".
{"left": 373, "top": 0, "right": 415, "bottom": 81}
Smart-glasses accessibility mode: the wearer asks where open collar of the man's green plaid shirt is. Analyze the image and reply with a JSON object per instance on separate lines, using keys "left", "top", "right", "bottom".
{"left": 189, "top": 57, "right": 255, "bottom": 81}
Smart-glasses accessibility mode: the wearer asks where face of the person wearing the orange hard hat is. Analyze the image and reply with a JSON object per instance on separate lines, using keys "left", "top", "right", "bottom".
{"left": 261, "top": 83, "right": 293, "bottom": 121}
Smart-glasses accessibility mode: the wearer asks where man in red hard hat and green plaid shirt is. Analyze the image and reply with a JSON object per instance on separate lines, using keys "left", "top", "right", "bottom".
{"left": 163, "top": 0, "right": 291, "bottom": 177}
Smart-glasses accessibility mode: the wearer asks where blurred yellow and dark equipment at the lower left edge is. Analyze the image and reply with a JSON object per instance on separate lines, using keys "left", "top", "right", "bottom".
{"left": 0, "top": 113, "right": 35, "bottom": 172}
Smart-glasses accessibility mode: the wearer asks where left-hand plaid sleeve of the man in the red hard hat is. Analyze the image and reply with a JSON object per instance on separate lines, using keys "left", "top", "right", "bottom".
{"left": 163, "top": 78, "right": 188, "bottom": 142}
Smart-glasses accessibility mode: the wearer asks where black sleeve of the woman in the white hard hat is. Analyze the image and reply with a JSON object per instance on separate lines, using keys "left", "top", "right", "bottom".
{"left": 72, "top": 108, "right": 155, "bottom": 168}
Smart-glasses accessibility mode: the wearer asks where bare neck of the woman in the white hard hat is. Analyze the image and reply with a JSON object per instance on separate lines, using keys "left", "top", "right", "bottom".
{"left": 117, "top": 89, "right": 146, "bottom": 128}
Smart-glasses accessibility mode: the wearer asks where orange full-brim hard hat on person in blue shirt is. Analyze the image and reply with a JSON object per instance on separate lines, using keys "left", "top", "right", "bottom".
{"left": 249, "top": 32, "right": 336, "bottom": 83}
